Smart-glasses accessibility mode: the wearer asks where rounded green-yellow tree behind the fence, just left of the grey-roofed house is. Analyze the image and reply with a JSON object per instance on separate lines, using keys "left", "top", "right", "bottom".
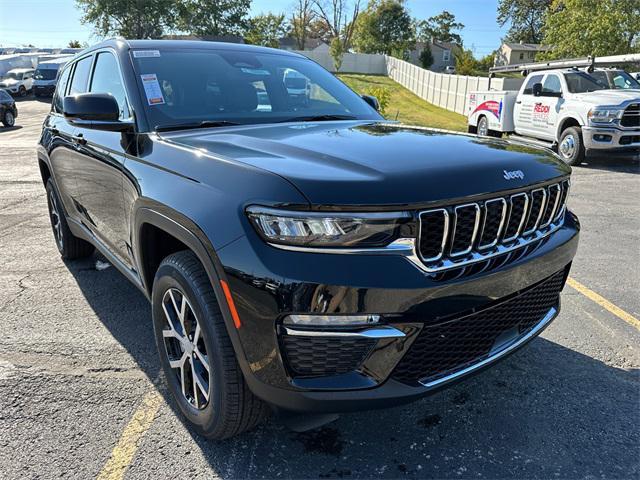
{"left": 353, "top": 0, "right": 415, "bottom": 58}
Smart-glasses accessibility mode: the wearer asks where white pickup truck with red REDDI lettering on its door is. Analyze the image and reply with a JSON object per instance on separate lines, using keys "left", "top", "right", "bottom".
{"left": 468, "top": 68, "right": 640, "bottom": 165}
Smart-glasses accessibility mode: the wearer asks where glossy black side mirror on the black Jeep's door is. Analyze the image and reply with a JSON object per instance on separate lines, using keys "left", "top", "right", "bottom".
{"left": 62, "top": 93, "right": 133, "bottom": 132}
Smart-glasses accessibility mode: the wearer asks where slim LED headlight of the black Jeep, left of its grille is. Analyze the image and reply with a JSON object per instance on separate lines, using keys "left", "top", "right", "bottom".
{"left": 247, "top": 207, "right": 413, "bottom": 248}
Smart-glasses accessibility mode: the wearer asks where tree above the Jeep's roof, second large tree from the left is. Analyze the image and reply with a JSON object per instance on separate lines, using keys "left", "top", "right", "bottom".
{"left": 175, "top": 0, "right": 251, "bottom": 36}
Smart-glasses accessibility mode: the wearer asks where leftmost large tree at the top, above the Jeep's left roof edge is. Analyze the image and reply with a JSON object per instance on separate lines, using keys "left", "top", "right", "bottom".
{"left": 76, "top": 0, "right": 175, "bottom": 38}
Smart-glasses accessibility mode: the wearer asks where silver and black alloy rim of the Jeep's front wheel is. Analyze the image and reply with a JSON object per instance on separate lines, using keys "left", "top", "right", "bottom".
{"left": 162, "top": 288, "right": 211, "bottom": 410}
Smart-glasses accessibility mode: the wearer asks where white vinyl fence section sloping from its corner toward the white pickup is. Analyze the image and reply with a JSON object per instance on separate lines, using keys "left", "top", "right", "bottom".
{"left": 386, "top": 57, "right": 523, "bottom": 115}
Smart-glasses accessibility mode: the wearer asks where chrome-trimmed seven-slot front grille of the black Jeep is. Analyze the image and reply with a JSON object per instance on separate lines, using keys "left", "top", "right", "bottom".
{"left": 418, "top": 180, "right": 569, "bottom": 272}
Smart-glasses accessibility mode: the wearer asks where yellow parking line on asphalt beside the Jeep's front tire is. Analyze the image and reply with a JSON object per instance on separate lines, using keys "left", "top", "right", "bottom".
{"left": 98, "top": 392, "right": 162, "bottom": 480}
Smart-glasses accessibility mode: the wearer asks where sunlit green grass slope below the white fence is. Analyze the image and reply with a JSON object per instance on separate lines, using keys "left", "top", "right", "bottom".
{"left": 338, "top": 74, "right": 467, "bottom": 132}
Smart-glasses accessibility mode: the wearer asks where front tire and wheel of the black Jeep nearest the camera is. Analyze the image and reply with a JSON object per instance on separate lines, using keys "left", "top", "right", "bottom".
{"left": 152, "top": 250, "right": 269, "bottom": 440}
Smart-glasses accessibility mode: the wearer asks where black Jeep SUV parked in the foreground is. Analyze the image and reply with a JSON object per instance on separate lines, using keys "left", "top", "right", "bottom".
{"left": 38, "top": 40, "right": 579, "bottom": 438}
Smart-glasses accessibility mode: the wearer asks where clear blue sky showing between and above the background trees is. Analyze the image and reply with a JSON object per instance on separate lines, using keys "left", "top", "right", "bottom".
{"left": 0, "top": 0, "right": 506, "bottom": 56}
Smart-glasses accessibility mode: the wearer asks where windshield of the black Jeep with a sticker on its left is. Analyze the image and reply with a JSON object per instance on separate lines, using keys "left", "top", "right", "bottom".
{"left": 132, "top": 49, "right": 382, "bottom": 129}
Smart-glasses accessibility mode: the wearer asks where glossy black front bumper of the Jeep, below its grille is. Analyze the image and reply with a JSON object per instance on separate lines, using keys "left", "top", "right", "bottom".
{"left": 218, "top": 214, "right": 579, "bottom": 412}
